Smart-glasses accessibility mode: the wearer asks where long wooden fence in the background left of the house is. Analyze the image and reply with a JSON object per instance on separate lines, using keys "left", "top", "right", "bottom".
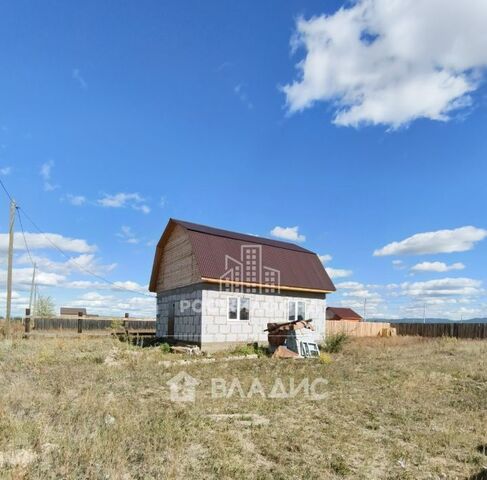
{"left": 30, "top": 316, "right": 156, "bottom": 331}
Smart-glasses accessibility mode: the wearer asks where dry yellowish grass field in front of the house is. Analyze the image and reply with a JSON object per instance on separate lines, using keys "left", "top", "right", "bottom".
{"left": 0, "top": 337, "right": 487, "bottom": 479}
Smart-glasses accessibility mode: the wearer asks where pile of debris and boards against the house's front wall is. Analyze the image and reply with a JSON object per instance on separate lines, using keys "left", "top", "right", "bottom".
{"left": 264, "top": 320, "right": 320, "bottom": 358}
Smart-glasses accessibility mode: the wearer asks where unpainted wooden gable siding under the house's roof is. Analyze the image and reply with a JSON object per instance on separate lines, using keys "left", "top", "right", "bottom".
{"left": 157, "top": 225, "right": 201, "bottom": 292}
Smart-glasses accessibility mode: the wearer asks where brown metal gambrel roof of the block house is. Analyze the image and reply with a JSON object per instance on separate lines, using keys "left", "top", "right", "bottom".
{"left": 149, "top": 219, "right": 335, "bottom": 293}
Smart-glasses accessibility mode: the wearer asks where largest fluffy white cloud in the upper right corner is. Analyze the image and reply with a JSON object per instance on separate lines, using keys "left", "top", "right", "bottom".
{"left": 283, "top": 0, "right": 487, "bottom": 128}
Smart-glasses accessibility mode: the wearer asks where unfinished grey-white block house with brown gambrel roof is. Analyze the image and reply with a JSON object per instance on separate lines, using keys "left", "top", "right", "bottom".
{"left": 149, "top": 219, "right": 335, "bottom": 350}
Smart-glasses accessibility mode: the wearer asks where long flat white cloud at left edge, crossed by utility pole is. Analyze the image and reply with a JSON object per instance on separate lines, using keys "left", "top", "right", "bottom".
{"left": 0, "top": 232, "right": 97, "bottom": 253}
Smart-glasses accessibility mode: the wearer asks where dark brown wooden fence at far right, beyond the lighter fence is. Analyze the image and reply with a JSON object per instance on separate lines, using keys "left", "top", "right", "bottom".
{"left": 391, "top": 322, "right": 487, "bottom": 338}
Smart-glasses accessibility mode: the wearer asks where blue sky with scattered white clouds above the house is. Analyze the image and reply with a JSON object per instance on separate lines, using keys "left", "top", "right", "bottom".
{"left": 0, "top": 0, "right": 487, "bottom": 320}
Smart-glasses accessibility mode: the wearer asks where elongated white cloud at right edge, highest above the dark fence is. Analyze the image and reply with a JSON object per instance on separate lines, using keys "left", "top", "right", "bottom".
{"left": 374, "top": 226, "right": 487, "bottom": 256}
